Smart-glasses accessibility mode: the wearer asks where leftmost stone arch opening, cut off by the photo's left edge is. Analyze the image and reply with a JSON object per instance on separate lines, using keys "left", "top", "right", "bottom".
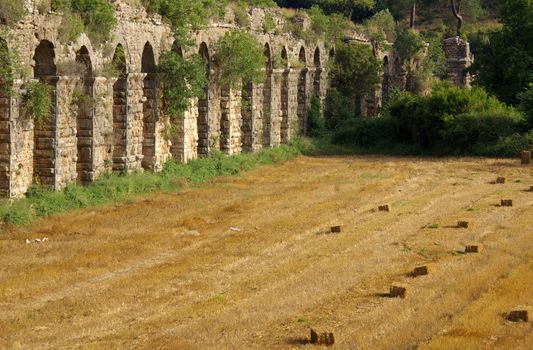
{"left": 0, "top": 38, "right": 12, "bottom": 197}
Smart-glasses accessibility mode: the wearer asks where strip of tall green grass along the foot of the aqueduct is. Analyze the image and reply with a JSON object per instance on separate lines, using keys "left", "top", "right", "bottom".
{"left": 0, "top": 139, "right": 308, "bottom": 225}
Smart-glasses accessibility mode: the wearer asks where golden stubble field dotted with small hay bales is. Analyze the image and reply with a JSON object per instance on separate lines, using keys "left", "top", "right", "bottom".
{"left": 0, "top": 157, "right": 533, "bottom": 349}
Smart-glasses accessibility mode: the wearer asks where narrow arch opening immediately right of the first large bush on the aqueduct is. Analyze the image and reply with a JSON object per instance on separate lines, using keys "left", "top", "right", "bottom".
{"left": 197, "top": 42, "right": 211, "bottom": 156}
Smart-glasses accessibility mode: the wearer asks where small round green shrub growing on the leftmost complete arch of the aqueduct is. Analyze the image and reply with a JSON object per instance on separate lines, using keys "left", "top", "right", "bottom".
{"left": 22, "top": 81, "right": 53, "bottom": 127}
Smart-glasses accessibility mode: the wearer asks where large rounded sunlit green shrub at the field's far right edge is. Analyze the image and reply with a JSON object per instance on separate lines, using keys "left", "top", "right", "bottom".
{"left": 388, "top": 83, "right": 524, "bottom": 150}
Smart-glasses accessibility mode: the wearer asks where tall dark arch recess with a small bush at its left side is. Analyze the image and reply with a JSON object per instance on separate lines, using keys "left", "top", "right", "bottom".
{"left": 33, "top": 40, "right": 58, "bottom": 187}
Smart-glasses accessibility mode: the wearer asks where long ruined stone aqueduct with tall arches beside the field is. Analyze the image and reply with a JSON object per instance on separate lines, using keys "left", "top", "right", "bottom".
{"left": 0, "top": 0, "right": 466, "bottom": 197}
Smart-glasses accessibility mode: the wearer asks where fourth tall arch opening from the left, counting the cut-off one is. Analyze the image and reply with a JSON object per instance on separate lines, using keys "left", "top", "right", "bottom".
{"left": 112, "top": 44, "right": 128, "bottom": 171}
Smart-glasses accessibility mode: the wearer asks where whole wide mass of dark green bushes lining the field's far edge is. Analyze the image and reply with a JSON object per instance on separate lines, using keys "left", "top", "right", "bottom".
{"left": 335, "top": 83, "right": 533, "bottom": 156}
